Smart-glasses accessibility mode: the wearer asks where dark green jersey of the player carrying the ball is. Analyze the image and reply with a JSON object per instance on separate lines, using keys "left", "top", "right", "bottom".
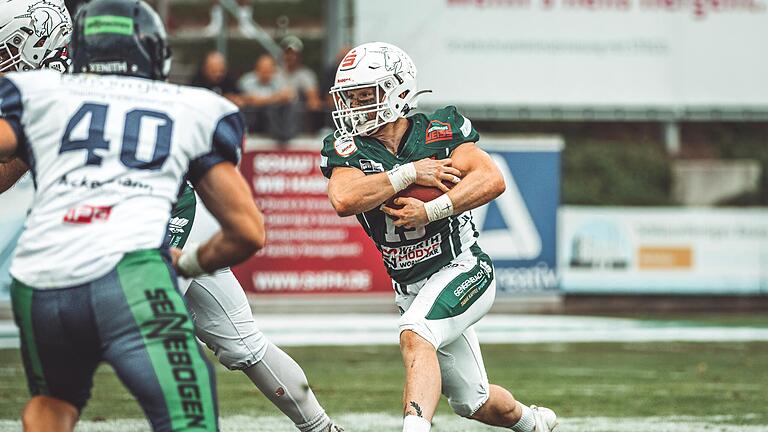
{"left": 320, "top": 106, "right": 480, "bottom": 285}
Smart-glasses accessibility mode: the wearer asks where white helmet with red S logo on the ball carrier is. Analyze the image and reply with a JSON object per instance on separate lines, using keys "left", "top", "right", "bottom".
{"left": 330, "top": 42, "right": 429, "bottom": 138}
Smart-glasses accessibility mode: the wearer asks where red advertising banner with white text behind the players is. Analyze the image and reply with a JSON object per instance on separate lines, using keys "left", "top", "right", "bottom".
{"left": 234, "top": 151, "right": 392, "bottom": 294}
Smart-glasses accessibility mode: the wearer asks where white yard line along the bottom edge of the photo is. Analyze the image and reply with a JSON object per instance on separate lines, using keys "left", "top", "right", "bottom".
{"left": 0, "top": 413, "right": 768, "bottom": 432}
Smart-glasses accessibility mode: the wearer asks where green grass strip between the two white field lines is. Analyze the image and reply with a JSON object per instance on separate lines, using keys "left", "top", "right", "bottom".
{"left": 0, "top": 343, "right": 768, "bottom": 431}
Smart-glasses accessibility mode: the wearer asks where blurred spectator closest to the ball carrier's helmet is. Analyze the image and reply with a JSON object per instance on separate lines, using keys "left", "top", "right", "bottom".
{"left": 280, "top": 36, "right": 324, "bottom": 131}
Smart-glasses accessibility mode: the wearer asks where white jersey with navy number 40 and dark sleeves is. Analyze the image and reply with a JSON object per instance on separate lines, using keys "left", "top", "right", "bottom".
{"left": 0, "top": 71, "right": 244, "bottom": 288}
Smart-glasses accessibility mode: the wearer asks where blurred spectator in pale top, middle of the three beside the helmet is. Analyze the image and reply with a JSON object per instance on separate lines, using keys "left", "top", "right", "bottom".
{"left": 237, "top": 54, "right": 299, "bottom": 145}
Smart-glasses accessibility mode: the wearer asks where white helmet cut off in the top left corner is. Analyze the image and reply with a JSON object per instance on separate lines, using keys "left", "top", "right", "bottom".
{"left": 0, "top": 0, "right": 72, "bottom": 73}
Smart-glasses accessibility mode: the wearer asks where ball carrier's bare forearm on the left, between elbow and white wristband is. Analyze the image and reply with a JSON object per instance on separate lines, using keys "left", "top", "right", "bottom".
{"left": 328, "top": 173, "right": 395, "bottom": 217}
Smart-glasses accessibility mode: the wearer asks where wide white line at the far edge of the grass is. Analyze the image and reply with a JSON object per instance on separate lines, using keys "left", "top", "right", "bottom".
{"left": 0, "top": 314, "right": 768, "bottom": 348}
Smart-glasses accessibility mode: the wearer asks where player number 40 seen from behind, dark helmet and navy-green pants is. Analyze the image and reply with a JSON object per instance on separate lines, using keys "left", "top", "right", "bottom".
{"left": 0, "top": 0, "right": 265, "bottom": 432}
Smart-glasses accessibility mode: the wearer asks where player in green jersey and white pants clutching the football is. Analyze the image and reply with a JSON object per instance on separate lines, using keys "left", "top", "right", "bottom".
{"left": 321, "top": 42, "right": 557, "bottom": 432}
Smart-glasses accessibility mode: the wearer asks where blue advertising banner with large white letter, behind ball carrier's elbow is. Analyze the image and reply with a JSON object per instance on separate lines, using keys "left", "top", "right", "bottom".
{"left": 473, "top": 138, "right": 563, "bottom": 293}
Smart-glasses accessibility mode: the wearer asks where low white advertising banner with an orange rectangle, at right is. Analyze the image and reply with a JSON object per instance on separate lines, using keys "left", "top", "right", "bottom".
{"left": 558, "top": 206, "right": 768, "bottom": 294}
